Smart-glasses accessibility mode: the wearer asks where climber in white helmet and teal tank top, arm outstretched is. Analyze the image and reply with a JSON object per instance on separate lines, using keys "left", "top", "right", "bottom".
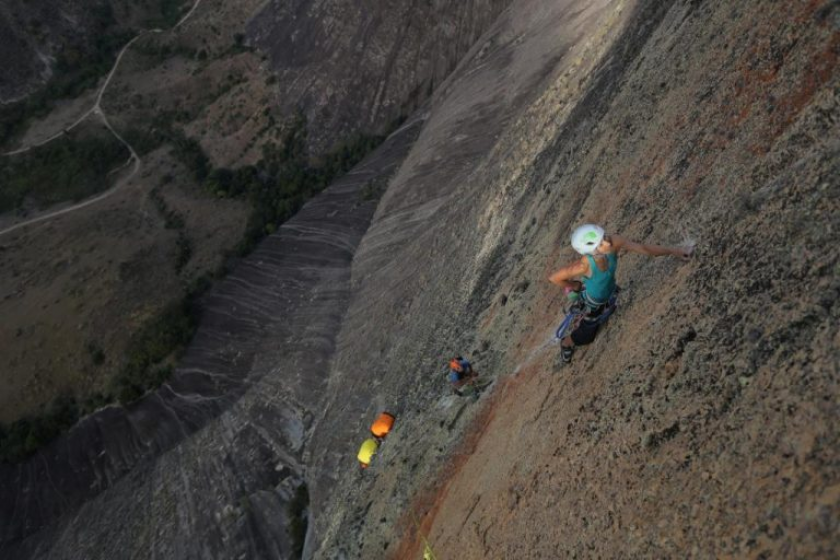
{"left": 549, "top": 224, "right": 694, "bottom": 363}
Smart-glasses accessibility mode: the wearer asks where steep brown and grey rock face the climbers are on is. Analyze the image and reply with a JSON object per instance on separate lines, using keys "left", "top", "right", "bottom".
{"left": 309, "top": 0, "right": 840, "bottom": 559}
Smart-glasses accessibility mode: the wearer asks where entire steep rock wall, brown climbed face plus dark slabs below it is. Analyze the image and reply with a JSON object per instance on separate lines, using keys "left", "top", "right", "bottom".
{"left": 0, "top": 0, "right": 840, "bottom": 559}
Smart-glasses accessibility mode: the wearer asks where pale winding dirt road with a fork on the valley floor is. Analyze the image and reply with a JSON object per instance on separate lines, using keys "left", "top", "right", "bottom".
{"left": 0, "top": 0, "right": 207, "bottom": 236}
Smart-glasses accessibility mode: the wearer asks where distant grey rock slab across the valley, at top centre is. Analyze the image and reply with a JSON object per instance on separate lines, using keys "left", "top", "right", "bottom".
{"left": 248, "top": 0, "right": 511, "bottom": 148}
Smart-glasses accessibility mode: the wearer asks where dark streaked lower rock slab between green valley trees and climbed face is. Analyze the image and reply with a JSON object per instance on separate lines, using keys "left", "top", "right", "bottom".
{"left": 0, "top": 119, "right": 421, "bottom": 559}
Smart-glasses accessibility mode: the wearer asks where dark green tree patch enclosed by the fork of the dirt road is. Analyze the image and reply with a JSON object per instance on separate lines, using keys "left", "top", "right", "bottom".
{"left": 0, "top": 127, "right": 129, "bottom": 212}
